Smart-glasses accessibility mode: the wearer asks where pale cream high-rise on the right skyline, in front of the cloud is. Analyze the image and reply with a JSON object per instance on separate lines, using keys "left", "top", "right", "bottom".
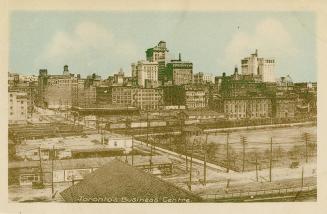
{"left": 241, "top": 50, "right": 276, "bottom": 82}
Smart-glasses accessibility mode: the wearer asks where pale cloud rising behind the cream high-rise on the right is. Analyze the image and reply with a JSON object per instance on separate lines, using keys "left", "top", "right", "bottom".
{"left": 222, "top": 18, "right": 298, "bottom": 72}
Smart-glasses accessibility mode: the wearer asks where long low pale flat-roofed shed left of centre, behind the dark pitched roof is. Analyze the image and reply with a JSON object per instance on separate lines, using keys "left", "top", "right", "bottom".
{"left": 16, "top": 134, "right": 132, "bottom": 160}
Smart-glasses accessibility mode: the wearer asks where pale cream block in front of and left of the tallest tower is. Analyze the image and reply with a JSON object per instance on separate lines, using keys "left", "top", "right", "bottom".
{"left": 132, "top": 60, "right": 158, "bottom": 87}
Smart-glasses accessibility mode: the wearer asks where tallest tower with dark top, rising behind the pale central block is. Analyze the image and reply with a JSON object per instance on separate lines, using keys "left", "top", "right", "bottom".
{"left": 145, "top": 41, "right": 168, "bottom": 84}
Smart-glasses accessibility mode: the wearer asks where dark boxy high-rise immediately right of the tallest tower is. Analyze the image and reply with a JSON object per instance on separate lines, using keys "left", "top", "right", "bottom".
{"left": 165, "top": 54, "right": 193, "bottom": 85}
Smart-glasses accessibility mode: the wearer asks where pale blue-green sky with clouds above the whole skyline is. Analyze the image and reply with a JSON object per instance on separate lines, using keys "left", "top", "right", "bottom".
{"left": 9, "top": 11, "right": 317, "bottom": 82}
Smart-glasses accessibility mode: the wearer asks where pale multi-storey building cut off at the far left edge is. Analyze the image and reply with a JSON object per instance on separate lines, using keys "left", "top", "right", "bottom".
{"left": 8, "top": 91, "right": 28, "bottom": 124}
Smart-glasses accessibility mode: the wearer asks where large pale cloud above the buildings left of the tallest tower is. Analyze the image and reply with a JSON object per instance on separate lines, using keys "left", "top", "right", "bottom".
{"left": 35, "top": 22, "right": 137, "bottom": 75}
